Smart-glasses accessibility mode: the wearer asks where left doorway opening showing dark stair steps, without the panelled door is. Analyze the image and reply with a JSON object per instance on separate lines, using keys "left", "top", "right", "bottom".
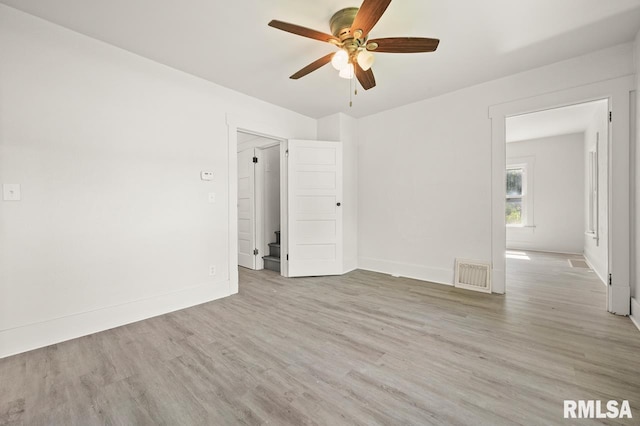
{"left": 237, "top": 131, "right": 283, "bottom": 273}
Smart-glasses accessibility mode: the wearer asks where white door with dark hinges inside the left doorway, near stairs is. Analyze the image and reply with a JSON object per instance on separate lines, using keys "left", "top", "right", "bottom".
{"left": 238, "top": 148, "right": 256, "bottom": 269}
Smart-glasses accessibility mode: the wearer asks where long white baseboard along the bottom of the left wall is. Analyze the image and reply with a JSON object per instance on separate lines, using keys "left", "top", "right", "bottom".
{"left": 0, "top": 281, "right": 229, "bottom": 358}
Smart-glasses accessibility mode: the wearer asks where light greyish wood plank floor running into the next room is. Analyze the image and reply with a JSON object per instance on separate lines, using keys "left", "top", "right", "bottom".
{"left": 0, "top": 252, "right": 640, "bottom": 425}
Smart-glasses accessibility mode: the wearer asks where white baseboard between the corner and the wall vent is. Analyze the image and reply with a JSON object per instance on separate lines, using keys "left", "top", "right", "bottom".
{"left": 358, "top": 257, "right": 454, "bottom": 286}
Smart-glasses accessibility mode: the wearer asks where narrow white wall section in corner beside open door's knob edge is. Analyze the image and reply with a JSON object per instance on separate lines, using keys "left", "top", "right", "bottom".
{"left": 318, "top": 113, "right": 358, "bottom": 272}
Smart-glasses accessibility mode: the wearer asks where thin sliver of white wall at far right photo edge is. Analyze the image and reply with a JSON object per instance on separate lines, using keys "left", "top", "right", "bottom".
{"left": 631, "top": 31, "right": 640, "bottom": 328}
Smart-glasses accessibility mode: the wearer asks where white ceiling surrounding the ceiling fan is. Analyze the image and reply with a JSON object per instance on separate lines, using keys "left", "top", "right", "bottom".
{"left": 0, "top": 0, "right": 640, "bottom": 118}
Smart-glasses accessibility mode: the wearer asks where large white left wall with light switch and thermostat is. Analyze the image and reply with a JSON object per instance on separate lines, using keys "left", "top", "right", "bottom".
{"left": 0, "top": 5, "right": 317, "bottom": 357}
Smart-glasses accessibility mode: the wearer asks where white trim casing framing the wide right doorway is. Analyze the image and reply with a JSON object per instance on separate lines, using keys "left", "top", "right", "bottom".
{"left": 488, "top": 75, "right": 635, "bottom": 315}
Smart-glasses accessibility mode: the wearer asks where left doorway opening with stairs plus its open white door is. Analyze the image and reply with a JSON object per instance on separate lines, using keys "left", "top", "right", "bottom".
{"left": 236, "top": 130, "right": 343, "bottom": 277}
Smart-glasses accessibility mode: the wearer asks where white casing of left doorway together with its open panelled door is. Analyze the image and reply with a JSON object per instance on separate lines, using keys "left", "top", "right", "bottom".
{"left": 227, "top": 115, "right": 344, "bottom": 294}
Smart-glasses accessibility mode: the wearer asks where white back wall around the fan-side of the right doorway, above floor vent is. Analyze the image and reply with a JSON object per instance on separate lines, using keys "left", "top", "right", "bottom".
{"left": 358, "top": 44, "right": 633, "bottom": 284}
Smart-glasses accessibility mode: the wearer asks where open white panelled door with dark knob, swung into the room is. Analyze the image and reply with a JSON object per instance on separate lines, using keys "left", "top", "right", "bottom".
{"left": 288, "top": 140, "right": 342, "bottom": 277}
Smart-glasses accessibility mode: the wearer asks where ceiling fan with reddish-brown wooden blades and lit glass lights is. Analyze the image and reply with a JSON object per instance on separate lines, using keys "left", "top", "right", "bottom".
{"left": 269, "top": 0, "right": 440, "bottom": 90}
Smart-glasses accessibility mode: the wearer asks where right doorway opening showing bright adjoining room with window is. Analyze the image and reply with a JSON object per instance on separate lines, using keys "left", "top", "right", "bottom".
{"left": 504, "top": 99, "right": 609, "bottom": 307}
